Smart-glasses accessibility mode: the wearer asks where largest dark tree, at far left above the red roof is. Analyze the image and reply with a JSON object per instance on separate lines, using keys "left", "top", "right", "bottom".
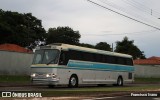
{"left": 0, "top": 9, "right": 46, "bottom": 48}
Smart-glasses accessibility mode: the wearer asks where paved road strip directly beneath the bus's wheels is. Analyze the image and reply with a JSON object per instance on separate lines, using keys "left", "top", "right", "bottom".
{"left": 0, "top": 84, "right": 160, "bottom": 91}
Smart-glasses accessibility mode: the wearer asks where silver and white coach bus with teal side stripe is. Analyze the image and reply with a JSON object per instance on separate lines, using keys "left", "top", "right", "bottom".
{"left": 31, "top": 43, "right": 134, "bottom": 88}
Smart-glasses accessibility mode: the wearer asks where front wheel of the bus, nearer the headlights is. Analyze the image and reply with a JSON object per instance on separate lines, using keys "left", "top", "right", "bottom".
{"left": 68, "top": 75, "right": 78, "bottom": 88}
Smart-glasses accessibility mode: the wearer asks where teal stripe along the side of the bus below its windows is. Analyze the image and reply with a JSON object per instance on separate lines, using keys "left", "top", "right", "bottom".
{"left": 31, "top": 60, "right": 135, "bottom": 72}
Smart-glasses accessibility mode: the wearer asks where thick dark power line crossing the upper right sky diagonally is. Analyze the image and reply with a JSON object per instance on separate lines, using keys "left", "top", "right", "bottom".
{"left": 87, "top": 0, "right": 160, "bottom": 30}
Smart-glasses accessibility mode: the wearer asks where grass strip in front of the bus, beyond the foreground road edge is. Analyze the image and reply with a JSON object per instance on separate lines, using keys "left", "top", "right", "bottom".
{"left": 41, "top": 85, "right": 160, "bottom": 96}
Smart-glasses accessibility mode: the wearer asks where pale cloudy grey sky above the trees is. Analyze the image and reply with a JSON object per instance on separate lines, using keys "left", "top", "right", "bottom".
{"left": 0, "top": 0, "right": 160, "bottom": 57}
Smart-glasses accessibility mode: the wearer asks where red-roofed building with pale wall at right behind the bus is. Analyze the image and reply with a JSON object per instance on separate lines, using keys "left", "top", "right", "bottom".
{"left": 134, "top": 56, "right": 160, "bottom": 78}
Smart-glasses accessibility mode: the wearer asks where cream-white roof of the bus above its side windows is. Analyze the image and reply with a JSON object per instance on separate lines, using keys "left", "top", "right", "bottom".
{"left": 47, "top": 43, "right": 132, "bottom": 58}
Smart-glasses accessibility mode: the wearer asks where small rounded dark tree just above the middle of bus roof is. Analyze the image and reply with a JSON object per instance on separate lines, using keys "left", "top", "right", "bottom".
{"left": 95, "top": 42, "right": 111, "bottom": 51}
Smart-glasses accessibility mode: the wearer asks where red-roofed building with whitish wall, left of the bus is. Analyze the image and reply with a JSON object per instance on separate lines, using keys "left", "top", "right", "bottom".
{"left": 0, "top": 44, "right": 33, "bottom": 75}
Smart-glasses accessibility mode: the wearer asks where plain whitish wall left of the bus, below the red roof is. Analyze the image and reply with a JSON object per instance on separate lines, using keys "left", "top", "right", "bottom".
{"left": 0, "top": 51, "right": 33, "bottom": 75}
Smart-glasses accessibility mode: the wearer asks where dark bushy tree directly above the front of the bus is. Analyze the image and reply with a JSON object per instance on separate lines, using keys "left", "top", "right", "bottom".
{"left": 46, "top": 27, "right": 81, "bottom": 45}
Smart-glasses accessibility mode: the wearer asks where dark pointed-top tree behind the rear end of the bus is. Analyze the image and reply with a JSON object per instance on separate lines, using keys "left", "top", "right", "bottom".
{"left": 115, "top": 37, "right": 146, "bottom": 59}
